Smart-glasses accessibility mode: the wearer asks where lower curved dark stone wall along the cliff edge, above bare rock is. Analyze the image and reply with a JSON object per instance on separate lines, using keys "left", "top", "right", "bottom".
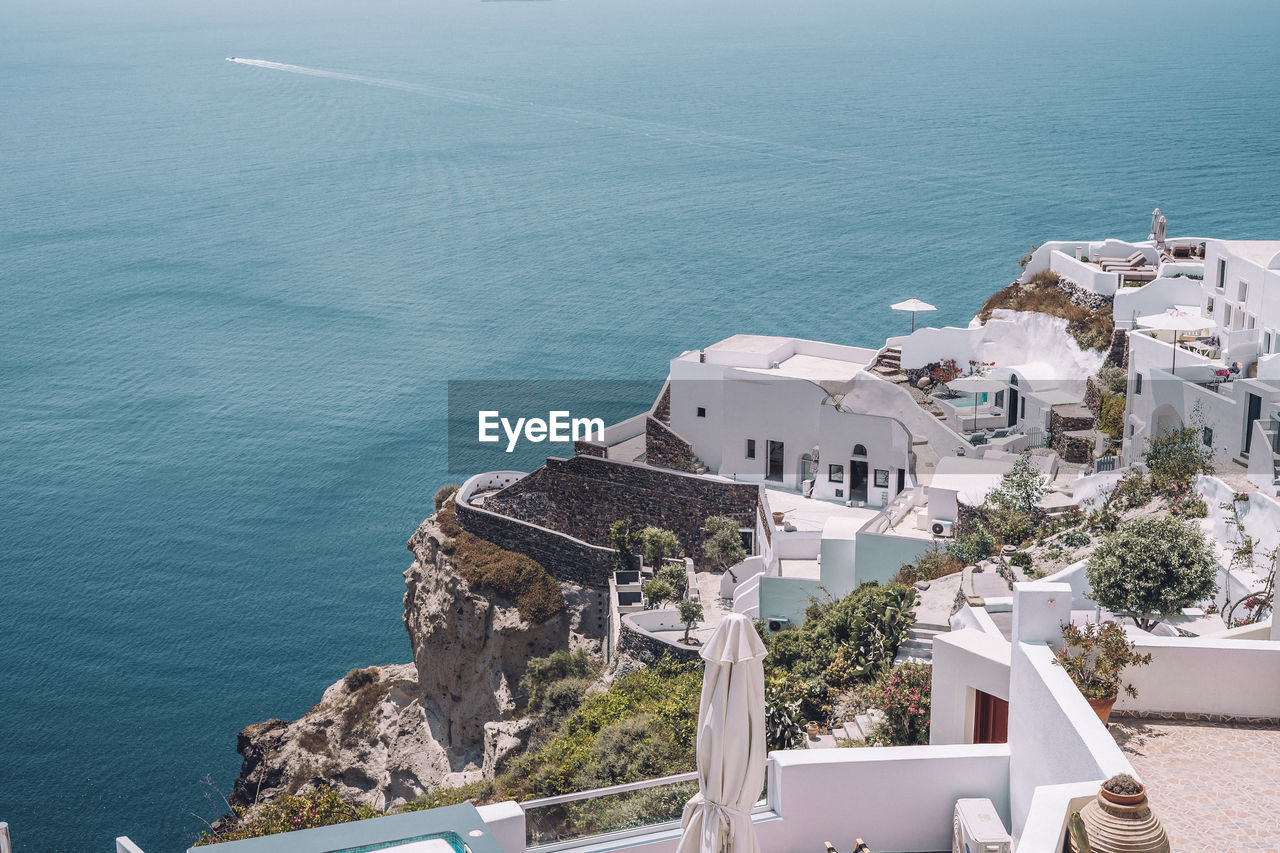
{"left": 457, "top": 499, "right": 614, "bottom": 587}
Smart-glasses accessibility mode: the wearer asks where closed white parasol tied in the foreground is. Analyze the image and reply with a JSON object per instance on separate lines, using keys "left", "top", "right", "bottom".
{"left": 676, "top": 613, "right": 767, "bottom": 853}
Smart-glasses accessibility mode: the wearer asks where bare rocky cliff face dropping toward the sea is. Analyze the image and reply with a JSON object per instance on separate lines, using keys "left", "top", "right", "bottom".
{"left": 230, "top": 507, "right": 607, "bottom": 808}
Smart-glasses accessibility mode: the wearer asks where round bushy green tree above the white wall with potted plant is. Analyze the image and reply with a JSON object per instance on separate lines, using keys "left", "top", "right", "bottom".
{"left": 1085, "top": 516, "right": 1217, "bottom": 630}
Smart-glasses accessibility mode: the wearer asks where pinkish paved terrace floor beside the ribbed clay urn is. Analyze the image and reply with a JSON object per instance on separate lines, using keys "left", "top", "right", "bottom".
{"left": 1110, "top": 717, "right": 1280, "bottom": 853}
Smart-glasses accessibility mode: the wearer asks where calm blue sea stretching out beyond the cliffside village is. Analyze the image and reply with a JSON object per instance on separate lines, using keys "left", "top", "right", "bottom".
{"left": 0, "top": 0, "right": 1280, "bottom": 853}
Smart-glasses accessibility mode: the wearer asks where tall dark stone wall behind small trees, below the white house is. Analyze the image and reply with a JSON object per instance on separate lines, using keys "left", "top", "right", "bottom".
{"left": 481, "top": 456, "right": 760, "bottom": 563}
